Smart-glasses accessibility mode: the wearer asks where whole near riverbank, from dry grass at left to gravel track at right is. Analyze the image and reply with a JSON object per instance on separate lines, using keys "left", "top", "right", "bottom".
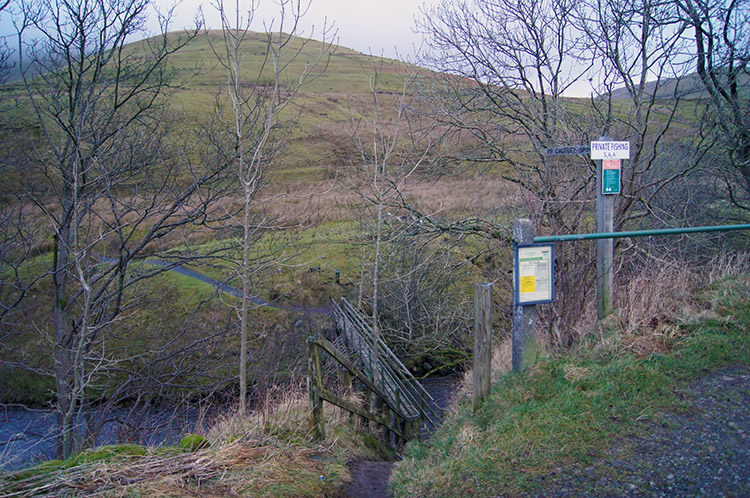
{"left": 0, "top": 260, "right": 750, "bottom": 498}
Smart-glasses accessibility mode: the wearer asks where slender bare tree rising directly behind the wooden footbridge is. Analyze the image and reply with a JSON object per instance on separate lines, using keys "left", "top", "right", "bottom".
{"left": 350, "top": 59, "right": 458, "bottom": 366}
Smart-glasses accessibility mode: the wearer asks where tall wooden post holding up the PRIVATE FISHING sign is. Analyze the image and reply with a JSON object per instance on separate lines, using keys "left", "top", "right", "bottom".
{"left": 596, "top": 136, "right": 615, "bottom": 320}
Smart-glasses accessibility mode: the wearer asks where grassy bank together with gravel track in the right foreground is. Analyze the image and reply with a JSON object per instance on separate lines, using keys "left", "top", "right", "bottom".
{"left": 392, "top": 266, "right": 750, "bottom": 498}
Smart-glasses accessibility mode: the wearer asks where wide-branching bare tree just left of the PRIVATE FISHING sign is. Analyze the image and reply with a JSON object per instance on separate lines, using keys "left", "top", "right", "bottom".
{"left": 420, "top": 0, "right": 601, "bottom": 345}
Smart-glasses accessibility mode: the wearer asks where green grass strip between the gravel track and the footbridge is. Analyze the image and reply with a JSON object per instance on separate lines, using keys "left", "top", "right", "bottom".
{"left": 393, "top": 276, "right": 750, "bottom": 498}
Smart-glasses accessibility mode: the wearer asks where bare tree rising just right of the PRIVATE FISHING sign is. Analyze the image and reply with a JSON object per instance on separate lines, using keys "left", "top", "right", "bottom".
{"left": 577, "top": 0, "right": 712, "bottom": 229}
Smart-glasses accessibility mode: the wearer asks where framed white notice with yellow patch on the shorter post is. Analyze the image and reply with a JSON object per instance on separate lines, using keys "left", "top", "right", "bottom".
{"left": 513, "top": 244, "right": 555, "bottom": 306}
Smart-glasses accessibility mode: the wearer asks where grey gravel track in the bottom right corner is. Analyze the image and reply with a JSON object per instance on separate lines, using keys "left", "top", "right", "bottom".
{"left": 530, "top": 366, "right": 750, "bottom": 498}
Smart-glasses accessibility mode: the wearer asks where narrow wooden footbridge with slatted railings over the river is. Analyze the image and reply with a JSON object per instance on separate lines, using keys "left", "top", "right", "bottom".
{"left": 308, "top": 299, "right": 439, "bottom": 442}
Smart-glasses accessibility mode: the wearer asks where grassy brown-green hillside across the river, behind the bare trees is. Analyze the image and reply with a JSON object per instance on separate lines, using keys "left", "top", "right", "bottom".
{"left": 0, "top": 27, "right": 488, "bottom": 420}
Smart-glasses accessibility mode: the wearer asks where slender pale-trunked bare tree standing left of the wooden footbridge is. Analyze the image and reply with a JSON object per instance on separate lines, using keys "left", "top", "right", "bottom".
{"left": 209, "top": 0, "right": 332, "bottom": 415}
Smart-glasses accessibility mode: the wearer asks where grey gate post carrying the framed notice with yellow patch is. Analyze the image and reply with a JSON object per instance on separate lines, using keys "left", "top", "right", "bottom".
{"left": 512, "top": 219, "right": 536, "bottom": 372}
